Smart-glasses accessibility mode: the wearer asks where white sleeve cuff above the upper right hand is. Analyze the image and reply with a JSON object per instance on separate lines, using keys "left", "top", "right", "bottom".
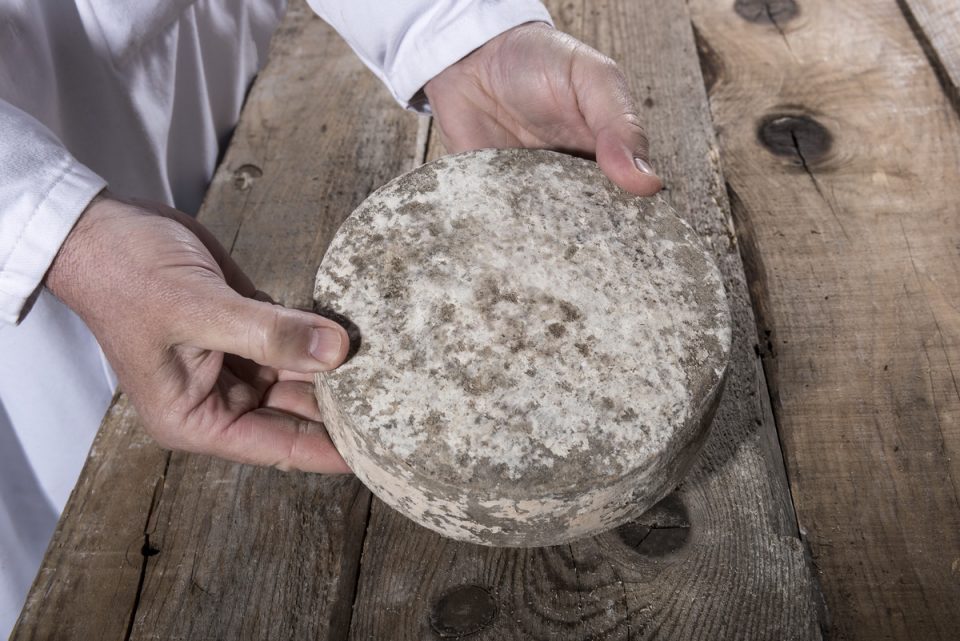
{"left": 307, "top": 0, "right": 553, "bottom": 109}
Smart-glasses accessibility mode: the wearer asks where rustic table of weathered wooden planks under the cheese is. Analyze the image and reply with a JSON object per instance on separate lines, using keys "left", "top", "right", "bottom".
{"left": 13, "top": 0, "right": 960, "bottom": 641}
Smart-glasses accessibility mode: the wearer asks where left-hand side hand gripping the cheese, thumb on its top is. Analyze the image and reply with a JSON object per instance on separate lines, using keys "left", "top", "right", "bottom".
{"left": 46, "top": 195, "right": 350, "bottom": 473}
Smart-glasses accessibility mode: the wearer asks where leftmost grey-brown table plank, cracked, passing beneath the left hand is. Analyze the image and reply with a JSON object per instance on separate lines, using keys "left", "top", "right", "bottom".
{"left": 13, "top": 2, "right": 418, "bottom": 640}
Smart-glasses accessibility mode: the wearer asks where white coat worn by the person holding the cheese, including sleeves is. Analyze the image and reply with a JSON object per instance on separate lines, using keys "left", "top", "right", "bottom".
{"left": 0, "top": 0, "right": 550, "bottom": 637}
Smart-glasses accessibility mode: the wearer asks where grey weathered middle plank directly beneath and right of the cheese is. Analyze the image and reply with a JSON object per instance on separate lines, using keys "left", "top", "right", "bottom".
{"left": 350, "top": 0, "right": 819, "bottom": 641}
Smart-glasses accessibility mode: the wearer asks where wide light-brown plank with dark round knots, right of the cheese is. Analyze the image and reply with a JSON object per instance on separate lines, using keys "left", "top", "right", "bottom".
{"left": 690, "top": 0, "right": 960, "bottom": 641}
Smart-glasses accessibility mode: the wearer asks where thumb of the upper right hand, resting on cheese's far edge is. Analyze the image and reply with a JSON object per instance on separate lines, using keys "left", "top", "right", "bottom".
{"left": 574, "top": 58, "right": 663, "bottom": 196}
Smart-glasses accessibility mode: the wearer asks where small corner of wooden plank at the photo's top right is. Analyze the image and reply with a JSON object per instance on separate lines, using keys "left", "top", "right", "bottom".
{"left": 897, "top": 0, "right": 960, "bottom": 114}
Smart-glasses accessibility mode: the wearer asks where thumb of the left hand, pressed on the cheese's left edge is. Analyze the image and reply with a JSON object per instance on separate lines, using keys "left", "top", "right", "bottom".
{"left": 180, "top": 283, "right": 350, "bottom": 372}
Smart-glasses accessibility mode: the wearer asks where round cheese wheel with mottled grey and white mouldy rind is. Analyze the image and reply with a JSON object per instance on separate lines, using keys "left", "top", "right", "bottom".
{"left": 314, "top": 150, "right": 731, "bottom": 546}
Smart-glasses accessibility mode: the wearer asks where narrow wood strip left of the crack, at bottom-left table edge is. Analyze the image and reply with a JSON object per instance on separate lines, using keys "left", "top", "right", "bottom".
{"left": 10, "top": 396, "right": 169, "bottom": 641}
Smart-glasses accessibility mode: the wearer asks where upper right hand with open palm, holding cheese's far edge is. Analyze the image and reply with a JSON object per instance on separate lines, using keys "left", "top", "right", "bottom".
{"left": 424, "top": 23, "right": 662, "bottom": 196}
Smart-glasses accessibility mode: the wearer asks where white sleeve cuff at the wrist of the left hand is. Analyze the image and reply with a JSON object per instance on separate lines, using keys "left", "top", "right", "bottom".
{"left": 0, "top": 100, "right": 106, "bottom": 323}
